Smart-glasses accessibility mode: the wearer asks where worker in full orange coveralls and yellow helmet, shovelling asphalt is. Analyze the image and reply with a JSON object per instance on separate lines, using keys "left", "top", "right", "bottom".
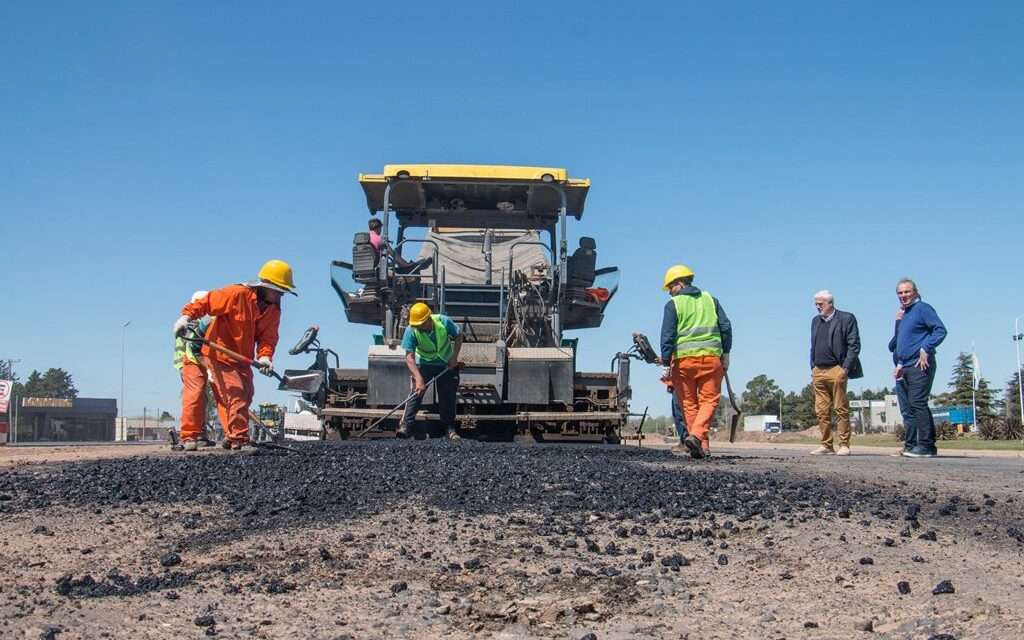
{"left": 174, "top": 260, "right": 298, "bottom": 454}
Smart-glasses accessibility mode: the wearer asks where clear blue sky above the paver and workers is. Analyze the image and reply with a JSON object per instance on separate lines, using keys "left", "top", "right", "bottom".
{"left": 0, "top": 2, "right": 1024, "bottom": 415}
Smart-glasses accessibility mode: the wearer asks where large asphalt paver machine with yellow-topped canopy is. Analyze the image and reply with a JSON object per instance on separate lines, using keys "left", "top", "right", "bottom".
{"left": 282, "top": 165, "right": 630, "bottom": 442}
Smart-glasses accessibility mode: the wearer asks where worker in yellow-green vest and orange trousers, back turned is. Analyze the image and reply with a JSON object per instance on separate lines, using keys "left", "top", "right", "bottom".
{"left": 659, "top": 264, "right": 732, "bottom": 458}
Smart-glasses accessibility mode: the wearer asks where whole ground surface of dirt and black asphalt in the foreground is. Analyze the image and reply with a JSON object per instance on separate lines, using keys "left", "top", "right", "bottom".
{"left": 0, "top": 441, "right": 1024, "bottom": 640}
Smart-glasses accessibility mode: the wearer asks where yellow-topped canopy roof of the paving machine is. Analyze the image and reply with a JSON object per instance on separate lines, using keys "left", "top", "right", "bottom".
{"left": 359, "top": 165, "right": 590, "bottom": 219}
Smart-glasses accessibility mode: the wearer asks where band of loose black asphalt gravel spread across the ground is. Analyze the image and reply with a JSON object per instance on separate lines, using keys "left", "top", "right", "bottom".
{"left": 0, "top": 440, "right": 1024, "bottom": 548}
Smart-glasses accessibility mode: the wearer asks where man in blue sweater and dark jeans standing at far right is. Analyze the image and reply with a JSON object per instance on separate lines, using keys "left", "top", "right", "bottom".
{"left": 889, "top": 278, "right": 946, "bottom": 458}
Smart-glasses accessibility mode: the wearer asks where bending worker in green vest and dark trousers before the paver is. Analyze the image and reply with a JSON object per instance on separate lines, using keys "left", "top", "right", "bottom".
{"left": 397, "top": 302, "right": 462, "bottom": 440}
